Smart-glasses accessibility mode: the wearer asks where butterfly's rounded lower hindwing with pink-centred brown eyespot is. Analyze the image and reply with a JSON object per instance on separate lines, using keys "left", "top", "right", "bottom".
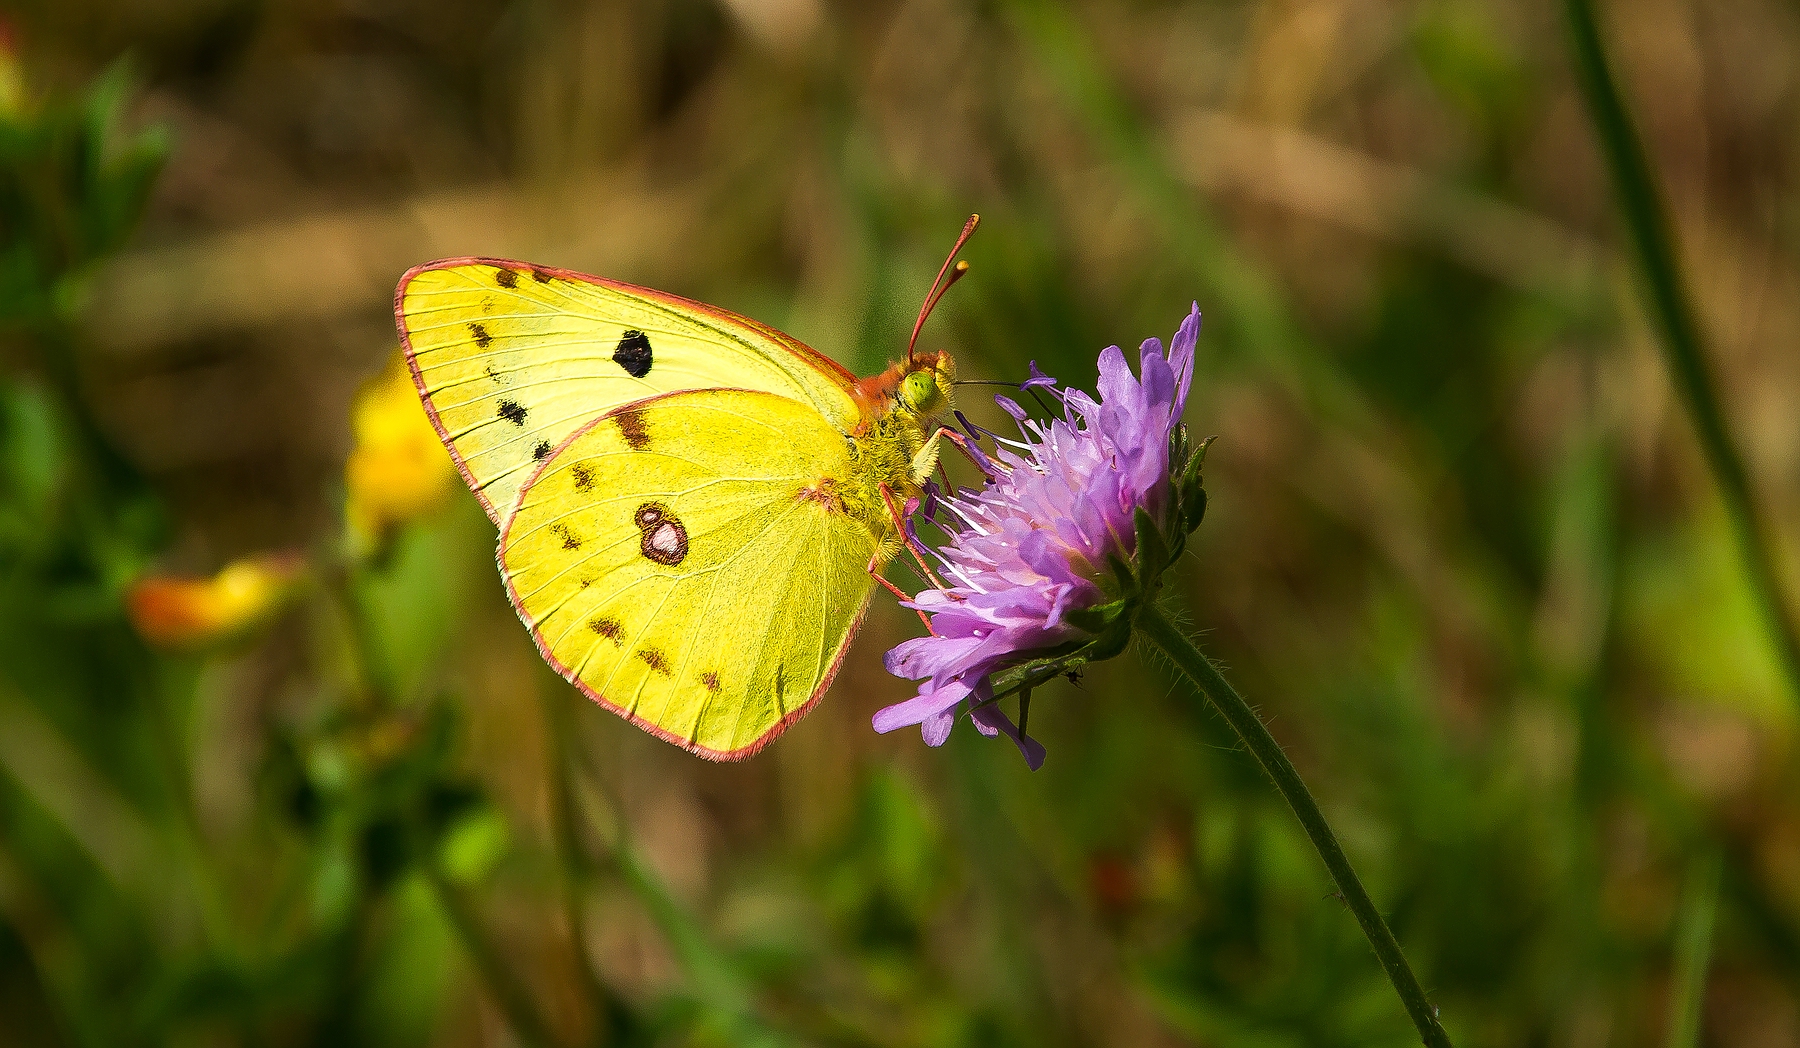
{"left": 500, "top": 389, "right": 877, "bottom": 758}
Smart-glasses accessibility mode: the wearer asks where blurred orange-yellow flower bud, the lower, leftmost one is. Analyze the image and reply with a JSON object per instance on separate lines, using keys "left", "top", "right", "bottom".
{"left": 126, "top": 555, "right": 302, "bottom": 648}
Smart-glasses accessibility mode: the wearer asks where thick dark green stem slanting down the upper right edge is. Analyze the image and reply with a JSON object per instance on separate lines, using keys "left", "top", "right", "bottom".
{"left": 1566, "top": 0, "right": 1800, "bottom": 702}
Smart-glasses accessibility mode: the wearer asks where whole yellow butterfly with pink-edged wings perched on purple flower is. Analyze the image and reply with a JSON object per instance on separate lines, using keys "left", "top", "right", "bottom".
{"left": 394, "top": 216, "right": 977, "bottom": 760}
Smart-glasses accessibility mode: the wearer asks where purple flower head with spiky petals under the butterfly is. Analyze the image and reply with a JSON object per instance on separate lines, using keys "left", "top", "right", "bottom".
{"left": 875, "top": 306, "right": 1201, "bottom": 769}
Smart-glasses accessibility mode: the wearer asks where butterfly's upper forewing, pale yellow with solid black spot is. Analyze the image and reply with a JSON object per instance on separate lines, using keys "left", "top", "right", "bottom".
{"left": 394, "top": 259, "right": 857, "bottom": 524}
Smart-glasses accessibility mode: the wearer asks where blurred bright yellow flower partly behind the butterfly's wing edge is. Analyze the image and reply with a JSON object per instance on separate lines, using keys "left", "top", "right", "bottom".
{"left": 344, "top": 351, "right": 457, "bottom": 546}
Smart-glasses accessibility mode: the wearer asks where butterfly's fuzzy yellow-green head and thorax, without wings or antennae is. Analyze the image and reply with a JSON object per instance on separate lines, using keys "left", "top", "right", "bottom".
{"left": 837, "top": 353, "right": 956, "bottom": 556}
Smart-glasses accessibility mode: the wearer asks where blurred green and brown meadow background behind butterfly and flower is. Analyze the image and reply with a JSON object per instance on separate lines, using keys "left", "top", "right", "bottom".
{"left": 0, "top": 0, "right": 1800, "bottom": 1048}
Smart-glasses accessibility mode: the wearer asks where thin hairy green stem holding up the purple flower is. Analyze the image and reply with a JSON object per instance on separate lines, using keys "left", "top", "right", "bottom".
{"left": 1138, "top": 605, "right": 1451, "bottom": 1048}
